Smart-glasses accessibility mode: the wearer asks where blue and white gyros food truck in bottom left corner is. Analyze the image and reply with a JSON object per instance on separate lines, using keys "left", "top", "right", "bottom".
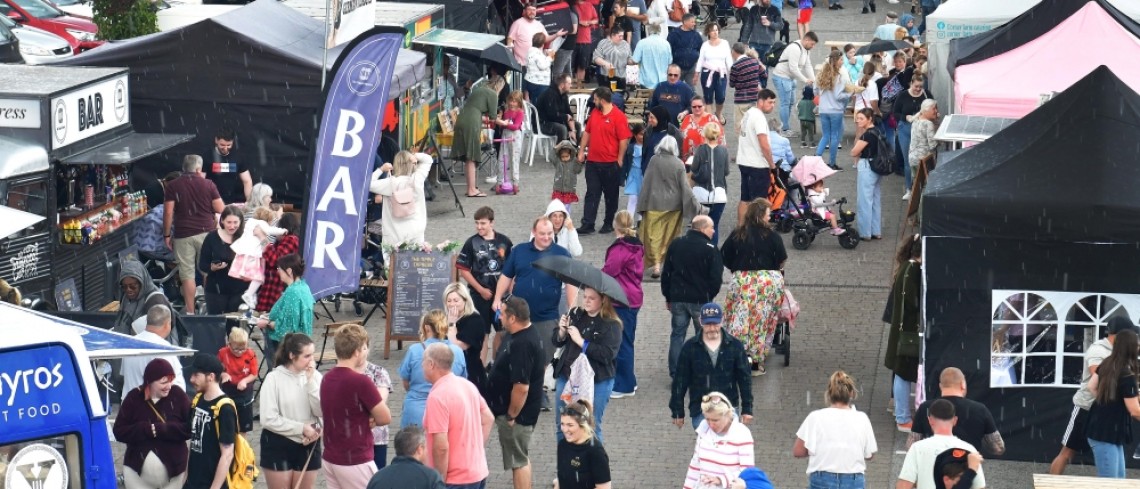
{"left": 0, "top": 302, "right": 193, "bottom": 489}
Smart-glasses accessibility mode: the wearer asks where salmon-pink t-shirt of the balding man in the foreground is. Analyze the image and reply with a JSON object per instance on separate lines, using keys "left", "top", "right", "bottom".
{"left": 424, "top": 374, "right": 490, "bottom": 484}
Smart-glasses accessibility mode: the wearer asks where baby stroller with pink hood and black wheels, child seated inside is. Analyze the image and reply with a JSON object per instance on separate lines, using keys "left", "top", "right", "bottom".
{"left": 791, "top": 156, "right": 860, "bottom": 250}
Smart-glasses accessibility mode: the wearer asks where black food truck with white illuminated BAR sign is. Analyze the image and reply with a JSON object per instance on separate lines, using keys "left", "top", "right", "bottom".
{"left": 0, "top": 66, "right": 192, "bottom": 310}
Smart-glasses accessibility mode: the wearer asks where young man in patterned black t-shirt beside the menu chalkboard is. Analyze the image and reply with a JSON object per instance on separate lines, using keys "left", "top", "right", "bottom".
{"left": 455, "top": 206, "right": 514, "bottom": 341}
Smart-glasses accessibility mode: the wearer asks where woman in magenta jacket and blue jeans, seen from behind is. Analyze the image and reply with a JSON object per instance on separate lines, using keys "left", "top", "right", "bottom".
{"left": 602, "top": 211, "right": 645, "bottom": 399}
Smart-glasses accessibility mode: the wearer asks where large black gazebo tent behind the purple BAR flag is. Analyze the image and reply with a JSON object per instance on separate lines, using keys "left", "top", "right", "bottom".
{"left": 49, "top": 0, "right": 425, "bottom": 203}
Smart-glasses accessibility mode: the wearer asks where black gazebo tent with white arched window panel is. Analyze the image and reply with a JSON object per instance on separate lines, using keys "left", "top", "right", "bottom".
{"left": 922, "top": 66, "right": 1140, "bottom": 463}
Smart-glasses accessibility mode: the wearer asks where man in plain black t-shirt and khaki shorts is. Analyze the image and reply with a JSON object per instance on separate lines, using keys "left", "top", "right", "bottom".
{"left": 487, "top": 296, "right": 546, "bottom": 489}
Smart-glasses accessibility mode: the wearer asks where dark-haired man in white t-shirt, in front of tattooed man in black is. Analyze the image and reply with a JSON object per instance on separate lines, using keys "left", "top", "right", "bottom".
{"left": 895, "top": 399, "right": 986, "bottom": 489}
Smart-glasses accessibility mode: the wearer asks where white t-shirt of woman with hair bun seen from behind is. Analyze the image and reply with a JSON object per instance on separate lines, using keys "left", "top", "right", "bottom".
{"left": 796, "top": 407, "right": 879, "bottom": 474}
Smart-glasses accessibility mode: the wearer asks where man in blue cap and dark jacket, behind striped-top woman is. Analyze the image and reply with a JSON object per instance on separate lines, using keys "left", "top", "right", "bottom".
{"left": 669, "top": 302, "right": 752, "bottom": 429}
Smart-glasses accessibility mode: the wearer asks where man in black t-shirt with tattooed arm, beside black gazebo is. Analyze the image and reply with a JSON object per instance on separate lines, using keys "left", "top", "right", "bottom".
{"left": 906, "top": 367, "right": 1005, "bottom": 456}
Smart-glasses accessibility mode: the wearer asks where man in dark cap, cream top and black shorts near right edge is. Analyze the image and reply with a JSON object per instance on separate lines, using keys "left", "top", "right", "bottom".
{"left": 1049, "top": 316, "right": 1137, "bottom": 475}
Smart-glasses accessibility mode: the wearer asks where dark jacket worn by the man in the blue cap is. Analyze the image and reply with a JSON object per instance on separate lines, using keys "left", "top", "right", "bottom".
{"left": 669, "top": 328, "right": 752, "bottom": 419}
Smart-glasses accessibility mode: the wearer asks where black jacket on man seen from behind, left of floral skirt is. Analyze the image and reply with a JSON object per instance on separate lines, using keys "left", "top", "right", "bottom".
{"left": 661, "top": 230, "right": 724, "bottom": 304}
